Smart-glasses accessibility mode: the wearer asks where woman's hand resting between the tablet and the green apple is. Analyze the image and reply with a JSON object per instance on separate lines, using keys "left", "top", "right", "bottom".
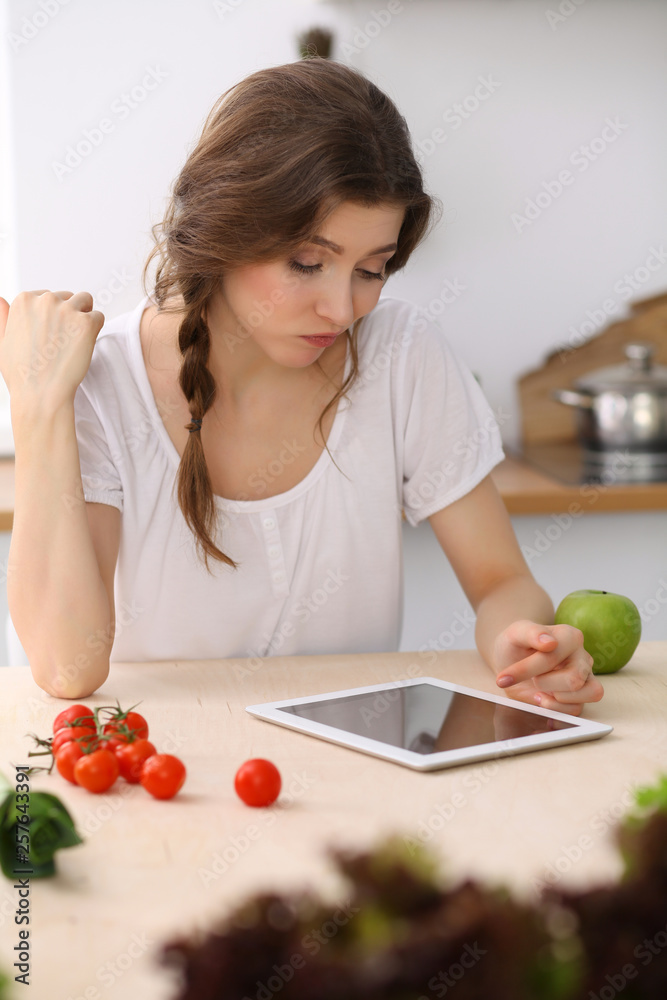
{"left": 493, "top": 620, "right": 604, "bottom": 715}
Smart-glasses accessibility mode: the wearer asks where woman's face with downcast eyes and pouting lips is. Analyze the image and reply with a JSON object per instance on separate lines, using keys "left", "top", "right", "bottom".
{"left": 209, "top": 202, "right": 405, "bottom": 368}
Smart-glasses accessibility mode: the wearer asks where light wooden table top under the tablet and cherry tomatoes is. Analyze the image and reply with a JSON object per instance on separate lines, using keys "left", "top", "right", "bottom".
{"left": 0, "top": 642, "right": 667, "bottom": 1000}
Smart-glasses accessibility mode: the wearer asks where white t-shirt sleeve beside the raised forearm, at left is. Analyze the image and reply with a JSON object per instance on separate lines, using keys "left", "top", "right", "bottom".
{"left": 74, "top": 379, "right": 123, "bottom": 513}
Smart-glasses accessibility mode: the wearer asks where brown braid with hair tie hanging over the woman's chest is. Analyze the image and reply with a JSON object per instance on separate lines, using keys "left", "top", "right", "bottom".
{"left": 178, "top": 299, "right": 237, "bottom": 572}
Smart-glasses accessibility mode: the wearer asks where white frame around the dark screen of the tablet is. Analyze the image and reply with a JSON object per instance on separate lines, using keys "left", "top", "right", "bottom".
{"left": 246, "top": 677, "right": 613, "bottom": 771}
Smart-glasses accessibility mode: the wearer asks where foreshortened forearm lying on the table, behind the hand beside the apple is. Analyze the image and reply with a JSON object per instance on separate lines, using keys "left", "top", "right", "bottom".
{"left": 475, "top": 576, "right": 554, "bottom": 674}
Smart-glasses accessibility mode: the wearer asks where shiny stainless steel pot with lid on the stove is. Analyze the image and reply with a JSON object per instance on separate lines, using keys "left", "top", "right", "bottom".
{"left": 552, "top": 342, "right": 667, "bottom": 453}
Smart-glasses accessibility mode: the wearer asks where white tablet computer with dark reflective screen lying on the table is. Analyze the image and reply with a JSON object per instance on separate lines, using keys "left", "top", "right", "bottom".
{"left": 246, "top": 677, "right": 612, "bottom": 771}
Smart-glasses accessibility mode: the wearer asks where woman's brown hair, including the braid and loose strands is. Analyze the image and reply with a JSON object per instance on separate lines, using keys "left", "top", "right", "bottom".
{"left": 142, "top": 57, "right": 441, "bottom": 572}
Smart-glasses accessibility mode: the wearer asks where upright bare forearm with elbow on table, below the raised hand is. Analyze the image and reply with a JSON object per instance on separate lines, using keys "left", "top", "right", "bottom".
{"left": 7, "top": 398, "right": 113, "bottom": 698}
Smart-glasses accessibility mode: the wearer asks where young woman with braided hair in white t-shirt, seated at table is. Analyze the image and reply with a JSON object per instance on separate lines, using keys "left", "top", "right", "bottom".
{"left": 0, "top": 59, "right": 602, "bottom": 715}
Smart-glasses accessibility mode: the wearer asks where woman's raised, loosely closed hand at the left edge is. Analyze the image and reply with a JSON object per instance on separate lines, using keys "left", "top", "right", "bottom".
{"left": 0, "top": 288, "right": 104, "bottom": 411}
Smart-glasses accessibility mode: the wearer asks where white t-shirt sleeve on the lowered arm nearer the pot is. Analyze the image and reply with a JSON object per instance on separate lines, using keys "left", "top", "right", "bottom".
{"left": 399, "top": 309, "right": 505, "bottom": 527}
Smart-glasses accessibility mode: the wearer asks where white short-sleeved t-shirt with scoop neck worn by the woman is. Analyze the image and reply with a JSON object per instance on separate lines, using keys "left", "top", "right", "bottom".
{"left": 64, "top": 296, "right": 504, "bottom": 661}
